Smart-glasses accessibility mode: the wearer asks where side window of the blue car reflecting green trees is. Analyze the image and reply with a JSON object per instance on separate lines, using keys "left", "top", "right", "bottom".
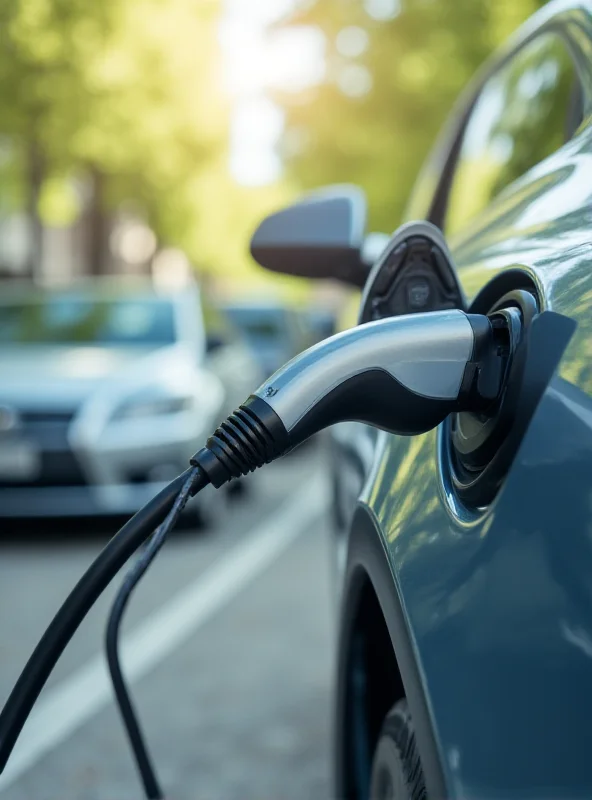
{"left": 445, "top": 34, "right": 581, "bottom": 235}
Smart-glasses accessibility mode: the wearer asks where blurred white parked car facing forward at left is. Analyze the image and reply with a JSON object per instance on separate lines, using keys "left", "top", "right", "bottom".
{"left": 0, "top": 281, "right": 259, "bottom": 517}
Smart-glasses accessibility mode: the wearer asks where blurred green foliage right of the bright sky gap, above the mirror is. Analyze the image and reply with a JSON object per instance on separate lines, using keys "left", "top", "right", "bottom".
{"left": 278, "top": 0, "right": 542, "bottom": 231}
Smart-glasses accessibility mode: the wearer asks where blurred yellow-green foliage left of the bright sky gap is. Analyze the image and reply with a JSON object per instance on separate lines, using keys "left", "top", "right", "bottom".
{"left": 0, "top": 0, "right": 284, "bottom": 284}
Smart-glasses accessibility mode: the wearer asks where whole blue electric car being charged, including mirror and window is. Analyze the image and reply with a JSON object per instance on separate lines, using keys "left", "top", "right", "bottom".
{"left": 252, "top": 0, "right": 592, "bottom": 800}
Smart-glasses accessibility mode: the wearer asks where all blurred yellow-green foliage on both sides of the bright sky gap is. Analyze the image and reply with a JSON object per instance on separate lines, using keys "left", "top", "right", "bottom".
{"left": 0, "top": 0, "right": 556, "bottom": 293}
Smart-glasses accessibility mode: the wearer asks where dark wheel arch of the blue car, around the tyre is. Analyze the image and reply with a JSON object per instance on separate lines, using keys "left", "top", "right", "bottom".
{"left": 333, "top": 504, "right": 447, "bottom": 800}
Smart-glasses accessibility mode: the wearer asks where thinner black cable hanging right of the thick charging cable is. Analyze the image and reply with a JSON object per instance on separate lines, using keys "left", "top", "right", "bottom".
{"left": 105, "top": 467, "right": 204, "bottom": 800}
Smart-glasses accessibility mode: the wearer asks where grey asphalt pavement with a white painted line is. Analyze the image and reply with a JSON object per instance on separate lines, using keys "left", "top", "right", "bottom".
{"left": 0, "top": 443, "right": 335, "bottom": 800}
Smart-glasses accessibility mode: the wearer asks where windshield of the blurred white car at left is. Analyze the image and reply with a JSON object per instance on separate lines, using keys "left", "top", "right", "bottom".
{"left": 0, "top": 295, "right": 176, "bottom": 345}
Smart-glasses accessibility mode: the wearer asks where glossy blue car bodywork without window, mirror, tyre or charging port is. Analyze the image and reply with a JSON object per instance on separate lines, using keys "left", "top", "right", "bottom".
{"left": 335, "top": 2, "right": 592, "bottom": 799}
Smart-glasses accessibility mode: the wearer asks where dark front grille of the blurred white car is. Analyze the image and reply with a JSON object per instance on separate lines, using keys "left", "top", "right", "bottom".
{"left": 0, "top": 410, "right": 86, "bottom": 488}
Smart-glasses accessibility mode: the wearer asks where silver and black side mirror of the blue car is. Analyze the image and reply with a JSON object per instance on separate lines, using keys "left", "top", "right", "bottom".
{"left": 251, "top": 184, "right": 369, "bottom": 287}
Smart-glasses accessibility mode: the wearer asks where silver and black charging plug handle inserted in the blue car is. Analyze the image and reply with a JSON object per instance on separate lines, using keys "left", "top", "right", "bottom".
{"left": 191, "top": 309, "right": 507, "bottom": 487}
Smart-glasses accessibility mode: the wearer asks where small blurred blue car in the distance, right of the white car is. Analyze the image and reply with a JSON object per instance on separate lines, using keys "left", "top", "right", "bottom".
{"left": 224, "top": 302, "right": 315, "bottom": 377}
